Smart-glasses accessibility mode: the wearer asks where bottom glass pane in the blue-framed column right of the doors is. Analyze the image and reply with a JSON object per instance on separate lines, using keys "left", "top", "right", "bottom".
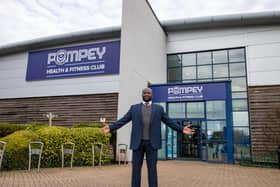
{"left": 208, "top": 142, "right": 227, "bottom": 162}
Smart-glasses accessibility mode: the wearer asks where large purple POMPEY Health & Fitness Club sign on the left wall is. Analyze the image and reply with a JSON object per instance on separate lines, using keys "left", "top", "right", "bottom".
{"left": 26, "top": 41, "right": 120, "bottom": 81}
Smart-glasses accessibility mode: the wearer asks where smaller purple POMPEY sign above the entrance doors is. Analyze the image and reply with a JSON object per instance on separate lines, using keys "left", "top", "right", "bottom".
{"left": 150, "top": 82, "right": 227, "bottom": 102}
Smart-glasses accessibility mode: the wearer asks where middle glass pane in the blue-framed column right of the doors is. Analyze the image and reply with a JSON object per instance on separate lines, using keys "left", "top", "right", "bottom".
{"left": 207, "top": 121, "right": 226, "bottom": 140}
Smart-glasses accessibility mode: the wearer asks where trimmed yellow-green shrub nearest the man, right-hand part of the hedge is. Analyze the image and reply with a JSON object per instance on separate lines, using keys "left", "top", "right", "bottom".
{"left": 35, "top": 127, "right": 110, "bottom": 167}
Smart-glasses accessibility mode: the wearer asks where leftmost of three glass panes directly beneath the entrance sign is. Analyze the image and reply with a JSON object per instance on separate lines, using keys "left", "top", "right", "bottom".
{"left": 168, "top": 103, "right": 186, "bottom": 118}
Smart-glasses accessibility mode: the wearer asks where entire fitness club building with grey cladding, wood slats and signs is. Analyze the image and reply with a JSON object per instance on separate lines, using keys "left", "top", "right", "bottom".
{"left": 0, "top": 0, "right": 280, "bottom": 163}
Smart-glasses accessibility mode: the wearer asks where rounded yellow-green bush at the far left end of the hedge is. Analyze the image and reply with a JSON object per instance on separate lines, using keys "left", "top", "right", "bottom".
{"left": 0, "top": 130, "right": 38, "bottom": 170}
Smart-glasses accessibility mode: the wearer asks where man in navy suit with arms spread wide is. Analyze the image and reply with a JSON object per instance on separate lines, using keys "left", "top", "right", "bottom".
{"left": 101, "top": 88, "right": 193, "bottom": 187}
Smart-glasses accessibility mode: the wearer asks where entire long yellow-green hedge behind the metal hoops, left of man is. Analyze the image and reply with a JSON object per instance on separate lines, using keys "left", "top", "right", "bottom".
{"left": 0, "top": 127, "right": 111, "bottom": 170}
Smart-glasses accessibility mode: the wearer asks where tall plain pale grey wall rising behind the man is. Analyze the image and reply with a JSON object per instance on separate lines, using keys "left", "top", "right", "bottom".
{"left": 117, "top": 0, "right": 166, "bottom": 161}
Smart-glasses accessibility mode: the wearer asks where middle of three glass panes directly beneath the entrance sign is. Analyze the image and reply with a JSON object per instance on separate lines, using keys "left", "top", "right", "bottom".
{"left": 187, "top": 102, "right": 204, "bottom": 118}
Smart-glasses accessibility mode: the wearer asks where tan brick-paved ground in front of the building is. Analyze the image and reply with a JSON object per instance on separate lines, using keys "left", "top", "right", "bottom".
{"left": 0, "top": 161, "right": 280, "bottom": 187}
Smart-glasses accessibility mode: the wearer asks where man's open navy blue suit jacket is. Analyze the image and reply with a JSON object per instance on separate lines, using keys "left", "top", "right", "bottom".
{"left": 109, "top": 103, "right": 183, "bottom": 150}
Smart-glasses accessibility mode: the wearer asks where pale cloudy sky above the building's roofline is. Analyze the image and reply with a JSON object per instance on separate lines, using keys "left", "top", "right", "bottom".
{"left": 0, "top": 0, "right": 280, "bottom": 46}
